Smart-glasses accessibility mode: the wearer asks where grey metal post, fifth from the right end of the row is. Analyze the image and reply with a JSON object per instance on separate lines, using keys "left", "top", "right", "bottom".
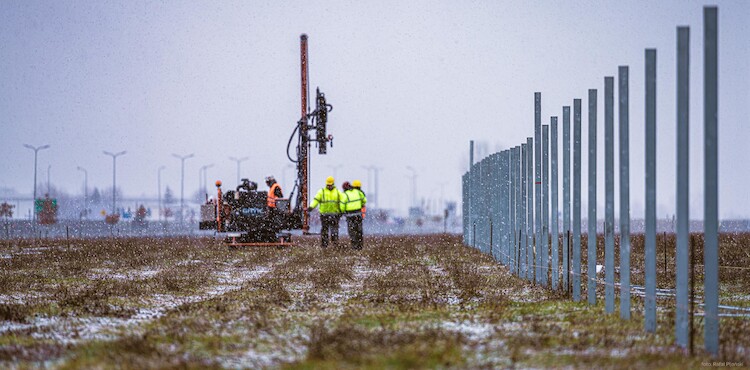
{"left": 604, "top": 77, "right": 615, "bottom": 313}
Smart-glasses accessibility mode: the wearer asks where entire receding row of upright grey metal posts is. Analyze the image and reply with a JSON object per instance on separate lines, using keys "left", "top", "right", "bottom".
{"left": 462, "top": 7, "right": 719, "bottom": 355}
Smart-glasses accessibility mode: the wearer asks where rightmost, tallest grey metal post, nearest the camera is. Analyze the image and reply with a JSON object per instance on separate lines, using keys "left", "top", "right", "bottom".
{"left": 703, "top": 6, "right": 719, "bottom": 356}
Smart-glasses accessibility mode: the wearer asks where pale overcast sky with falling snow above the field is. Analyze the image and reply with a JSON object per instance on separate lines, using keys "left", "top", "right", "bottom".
{"left": 0, "top": 0, "right": 750, "bottom": 218}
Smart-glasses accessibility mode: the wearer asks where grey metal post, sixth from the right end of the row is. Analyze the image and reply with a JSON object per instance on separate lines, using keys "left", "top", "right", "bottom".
{"left": 586, "top": 89, "right": 597, "bottom": 305}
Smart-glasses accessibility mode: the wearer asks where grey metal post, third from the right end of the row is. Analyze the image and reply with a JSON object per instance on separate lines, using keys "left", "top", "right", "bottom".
{"left": 644, "top": 49, "right": 656, "bottom": 333}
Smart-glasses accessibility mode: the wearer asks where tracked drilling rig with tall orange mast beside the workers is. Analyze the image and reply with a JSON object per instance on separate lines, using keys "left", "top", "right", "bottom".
{"left": 199, "top": 34, "right": 333, "bottom": 247}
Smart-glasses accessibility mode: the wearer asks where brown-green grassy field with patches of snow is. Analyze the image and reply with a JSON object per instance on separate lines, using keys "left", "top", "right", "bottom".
{"left": 0, "top": 235, "right": 750, "bottom": 369}
